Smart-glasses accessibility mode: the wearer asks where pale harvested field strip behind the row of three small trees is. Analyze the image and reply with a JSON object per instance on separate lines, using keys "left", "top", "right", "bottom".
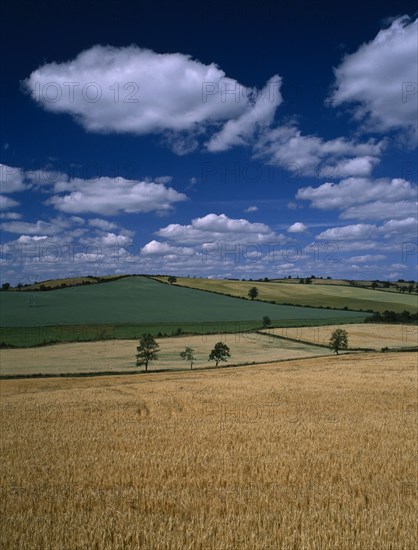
{"left": 0, "top": 333, "right": 330, "bottom": 375}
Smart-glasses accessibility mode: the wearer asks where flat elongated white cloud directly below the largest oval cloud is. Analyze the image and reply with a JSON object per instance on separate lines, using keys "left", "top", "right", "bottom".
{"left": 47, "top": 177, "right": 187, "bottom": 216}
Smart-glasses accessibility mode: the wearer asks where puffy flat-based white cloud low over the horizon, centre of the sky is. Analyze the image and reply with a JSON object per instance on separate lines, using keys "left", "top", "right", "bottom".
{"left": 157, "top": 214, "right": 278, "bottom": 244}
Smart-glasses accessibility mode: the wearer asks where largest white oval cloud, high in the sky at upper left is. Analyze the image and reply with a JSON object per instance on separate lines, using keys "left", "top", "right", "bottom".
{"left": 25, "top": 45, "right": 281, "bottom": 152}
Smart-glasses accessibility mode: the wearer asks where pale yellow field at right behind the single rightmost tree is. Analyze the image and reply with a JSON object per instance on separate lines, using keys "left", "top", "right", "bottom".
{"left": 264, "top": 323, "right": 418, "bottom": 350}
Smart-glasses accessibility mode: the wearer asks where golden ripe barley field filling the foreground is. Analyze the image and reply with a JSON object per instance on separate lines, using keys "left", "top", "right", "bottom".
{"left": 0, "top": 352, "right": 418, "bottom": 550}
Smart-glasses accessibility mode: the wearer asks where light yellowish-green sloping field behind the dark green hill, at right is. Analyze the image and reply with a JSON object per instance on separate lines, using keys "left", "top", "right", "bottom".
{"left": 154, "top": 277, "right": 418, "bottom": 313}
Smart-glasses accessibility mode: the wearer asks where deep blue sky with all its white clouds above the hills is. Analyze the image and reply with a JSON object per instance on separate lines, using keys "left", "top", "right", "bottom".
{"left": 0, "top": 0, "right": 418, "bottom": 284}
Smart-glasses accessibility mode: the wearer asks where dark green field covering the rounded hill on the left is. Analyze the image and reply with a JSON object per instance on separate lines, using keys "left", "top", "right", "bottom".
{"left": 0, "top": 276, "right": 365, "bottom": 346}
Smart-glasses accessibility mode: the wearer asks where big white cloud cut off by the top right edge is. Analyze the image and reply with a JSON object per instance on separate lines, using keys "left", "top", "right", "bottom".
{"left": 330, "top": 17, "right": 418, "bottom": 140}
